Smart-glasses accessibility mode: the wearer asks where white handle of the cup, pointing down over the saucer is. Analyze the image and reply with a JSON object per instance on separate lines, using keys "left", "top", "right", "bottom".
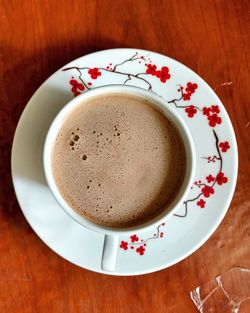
{"left": 102, "top": 235, "right": 119, "bottom": 272}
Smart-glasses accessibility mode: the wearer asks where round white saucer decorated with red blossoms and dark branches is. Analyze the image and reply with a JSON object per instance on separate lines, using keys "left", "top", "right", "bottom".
{"left": 12, "top": 49, "right": 238, "bottom": 275}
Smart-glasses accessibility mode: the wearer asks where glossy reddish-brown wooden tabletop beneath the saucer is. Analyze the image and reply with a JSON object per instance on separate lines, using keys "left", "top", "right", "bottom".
{"left": 0, "top": 0, "right": 250, "bottom": 313}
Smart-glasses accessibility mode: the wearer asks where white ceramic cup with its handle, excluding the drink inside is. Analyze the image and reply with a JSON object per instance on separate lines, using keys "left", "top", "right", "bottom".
{"left": 43, "top": 85, "right": 196, "bottom": 271}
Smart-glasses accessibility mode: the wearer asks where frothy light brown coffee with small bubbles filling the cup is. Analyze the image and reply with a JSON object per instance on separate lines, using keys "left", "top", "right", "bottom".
{"left": 52, "top": 93, "right": 186, "bottom": 227}
